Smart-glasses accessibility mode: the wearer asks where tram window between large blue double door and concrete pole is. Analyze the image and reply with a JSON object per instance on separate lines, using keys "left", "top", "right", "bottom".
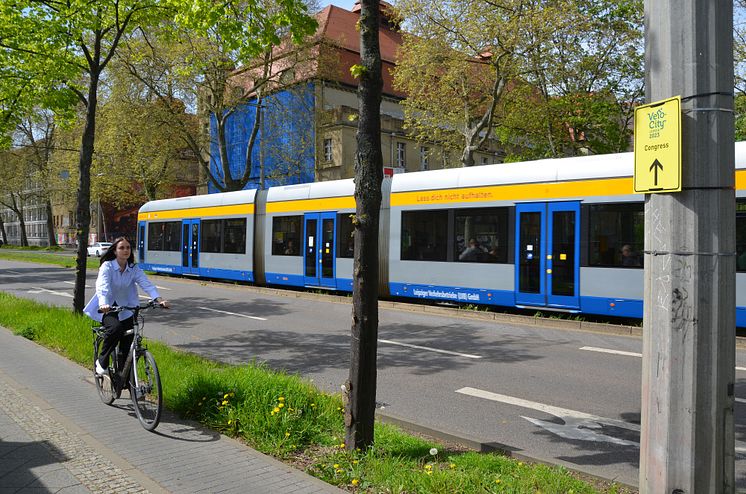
{"left": 588, "top": 203, "right": 645, "bottom": 268}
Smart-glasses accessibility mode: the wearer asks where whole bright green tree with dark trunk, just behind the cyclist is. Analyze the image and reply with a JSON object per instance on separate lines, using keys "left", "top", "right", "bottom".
{"left": 0, "top": 0, "right": 167, "bottom": 312}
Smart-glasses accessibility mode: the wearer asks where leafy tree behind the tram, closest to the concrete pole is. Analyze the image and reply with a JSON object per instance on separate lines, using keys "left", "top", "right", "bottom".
{"left": 508, "top": 0, "right": 644, "bottom": 159}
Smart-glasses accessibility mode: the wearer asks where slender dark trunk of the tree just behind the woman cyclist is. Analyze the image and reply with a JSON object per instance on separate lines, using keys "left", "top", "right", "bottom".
{"left": 73, "top": 71, "right": 101, "bottom": 313}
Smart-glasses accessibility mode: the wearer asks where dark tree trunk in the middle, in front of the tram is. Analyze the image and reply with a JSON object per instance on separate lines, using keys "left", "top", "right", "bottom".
{"left": 345, "top": 0, "right": 383, "bottom": 451}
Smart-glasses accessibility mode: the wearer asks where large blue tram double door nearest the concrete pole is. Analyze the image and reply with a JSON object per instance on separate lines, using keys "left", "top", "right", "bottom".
{"left": 515, "top": 202, "right": 580, "bottom": 310}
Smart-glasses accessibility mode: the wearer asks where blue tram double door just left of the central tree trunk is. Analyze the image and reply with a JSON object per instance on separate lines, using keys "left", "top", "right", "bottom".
{"left": 303, "top": 213, "right": 337, "bottom": 288}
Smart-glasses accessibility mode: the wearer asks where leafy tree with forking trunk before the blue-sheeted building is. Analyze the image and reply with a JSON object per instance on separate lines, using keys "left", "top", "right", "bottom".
{"left": 124, "top": 0, "right": 317, "bottom": 191}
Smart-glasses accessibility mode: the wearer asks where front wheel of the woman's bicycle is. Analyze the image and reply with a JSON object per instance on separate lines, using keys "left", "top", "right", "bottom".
{"left": 130, "top": 350, "right": 163, "bottom": 431}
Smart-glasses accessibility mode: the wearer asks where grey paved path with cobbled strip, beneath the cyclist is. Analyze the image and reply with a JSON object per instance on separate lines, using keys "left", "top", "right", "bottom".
{"left": 0, "top": 327, "right": 344, "bottom": 494}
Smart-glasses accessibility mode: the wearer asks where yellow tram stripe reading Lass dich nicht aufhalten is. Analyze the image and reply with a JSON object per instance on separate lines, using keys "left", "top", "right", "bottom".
{"left": 391, "top": 177, "right": 633, "bottom": 206}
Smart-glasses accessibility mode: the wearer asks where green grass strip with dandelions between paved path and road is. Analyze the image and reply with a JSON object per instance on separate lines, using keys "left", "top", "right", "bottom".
{"left": 0, "top": 292, "right": 627, "bottom": 494}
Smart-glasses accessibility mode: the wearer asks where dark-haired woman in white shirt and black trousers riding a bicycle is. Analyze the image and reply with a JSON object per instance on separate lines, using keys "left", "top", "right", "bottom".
{"left": 83, "top": 237, "right": 169, "bottom": 375}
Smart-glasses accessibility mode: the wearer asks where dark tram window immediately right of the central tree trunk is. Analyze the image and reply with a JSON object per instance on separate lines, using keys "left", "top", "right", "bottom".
{"left": 401, "top": 210, "right": 448, "bottom": 261}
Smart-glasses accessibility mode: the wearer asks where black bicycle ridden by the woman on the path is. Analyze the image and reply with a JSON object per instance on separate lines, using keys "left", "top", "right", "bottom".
{"left": 92, "top": 300, "right": 163, "bottom": 431}
